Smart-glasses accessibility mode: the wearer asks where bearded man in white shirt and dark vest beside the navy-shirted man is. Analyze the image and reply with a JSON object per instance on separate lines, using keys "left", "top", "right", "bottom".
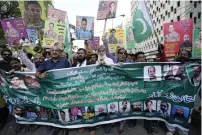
{"left": 72, "top": 48, "right": 92, "bottom": 67}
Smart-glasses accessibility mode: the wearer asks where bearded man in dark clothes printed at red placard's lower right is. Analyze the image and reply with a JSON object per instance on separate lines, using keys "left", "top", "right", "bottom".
{"left": 179, "top": 34, "right": 192, "bottom": 52}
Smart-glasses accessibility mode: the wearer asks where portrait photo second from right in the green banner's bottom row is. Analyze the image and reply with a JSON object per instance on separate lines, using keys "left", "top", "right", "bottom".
{"left": 157, "top": 100, "right": 171, "bottom": 119}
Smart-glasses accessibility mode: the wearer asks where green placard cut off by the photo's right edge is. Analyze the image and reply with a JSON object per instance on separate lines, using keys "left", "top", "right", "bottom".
{"left": 192, "top": 29, "right": 201, "bottom": 58}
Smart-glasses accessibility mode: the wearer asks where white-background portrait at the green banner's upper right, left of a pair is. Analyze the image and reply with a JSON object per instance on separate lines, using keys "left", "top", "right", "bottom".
{"left": 144, "top": 66, "right": 162, "bottom": 82}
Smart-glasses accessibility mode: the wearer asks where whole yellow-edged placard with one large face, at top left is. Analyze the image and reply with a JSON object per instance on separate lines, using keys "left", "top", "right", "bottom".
{"left": 19, "top": 0, "right": 46, "bottom": 27}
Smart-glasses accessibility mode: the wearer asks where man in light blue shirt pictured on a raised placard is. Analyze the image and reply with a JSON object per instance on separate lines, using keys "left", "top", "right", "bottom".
{"left": 76, "top": 18, "right": 92, "bottom": 40}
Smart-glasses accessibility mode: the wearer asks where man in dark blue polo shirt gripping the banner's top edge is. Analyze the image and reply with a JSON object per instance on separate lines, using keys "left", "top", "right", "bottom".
{"left": 36, "top": 46, "right": 70, "bottom": 135}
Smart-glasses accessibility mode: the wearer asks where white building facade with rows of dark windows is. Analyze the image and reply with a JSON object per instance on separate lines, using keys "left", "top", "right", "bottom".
{"left": 130, "top": 0, "right": 201, "bottom": 58}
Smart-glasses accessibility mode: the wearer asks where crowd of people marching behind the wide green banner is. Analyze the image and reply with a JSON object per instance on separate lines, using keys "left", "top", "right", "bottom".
{"left": 0, "top": 37, "right": 201, "bottom": 135}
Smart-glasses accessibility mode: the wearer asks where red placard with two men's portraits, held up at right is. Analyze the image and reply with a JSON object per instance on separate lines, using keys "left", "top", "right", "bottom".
{"left": 163, "top": 19, "right": 193, "bottom": 56}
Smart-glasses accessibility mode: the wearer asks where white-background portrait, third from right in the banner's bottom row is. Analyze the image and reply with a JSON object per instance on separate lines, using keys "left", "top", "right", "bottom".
{"left": 144, "top": 100, "right": 156, "bottom": 113}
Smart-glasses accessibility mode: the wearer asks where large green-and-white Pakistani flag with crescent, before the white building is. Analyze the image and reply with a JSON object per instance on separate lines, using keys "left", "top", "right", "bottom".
{"left": 133, "top": 0, "right": 154, "bottom": 43}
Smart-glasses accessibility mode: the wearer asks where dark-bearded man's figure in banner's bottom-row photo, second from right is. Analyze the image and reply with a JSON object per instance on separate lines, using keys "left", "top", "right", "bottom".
{"left": 158, "top": 101, "right": 170, "bottom": 119}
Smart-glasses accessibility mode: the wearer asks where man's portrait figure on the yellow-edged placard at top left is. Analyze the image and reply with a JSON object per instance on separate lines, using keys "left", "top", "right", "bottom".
{"left": 22, "top": 1, "right": 44, "bottom": 27}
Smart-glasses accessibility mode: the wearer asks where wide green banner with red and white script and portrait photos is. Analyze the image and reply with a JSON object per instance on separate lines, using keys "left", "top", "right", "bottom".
{"left": 0, "top": 63, "right": 200, "bottom": 130}
